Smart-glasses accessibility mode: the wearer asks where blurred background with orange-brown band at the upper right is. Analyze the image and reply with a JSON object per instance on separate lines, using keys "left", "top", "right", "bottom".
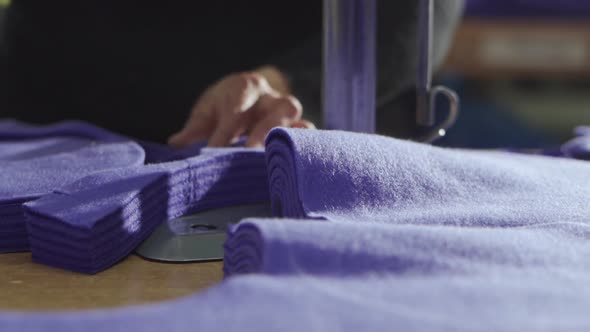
{"left": 0, "top": 0, "right": 590, "bottom": 148}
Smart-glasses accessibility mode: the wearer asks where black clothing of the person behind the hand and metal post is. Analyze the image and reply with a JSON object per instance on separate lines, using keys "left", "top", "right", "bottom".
{"left": 0, "top": 0, "right": 461, "bottom": 141}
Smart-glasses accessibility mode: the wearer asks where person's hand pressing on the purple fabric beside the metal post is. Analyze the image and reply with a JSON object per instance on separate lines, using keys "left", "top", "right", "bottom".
{"left": 168, "top": 67, "right": 315, "bottom": 147}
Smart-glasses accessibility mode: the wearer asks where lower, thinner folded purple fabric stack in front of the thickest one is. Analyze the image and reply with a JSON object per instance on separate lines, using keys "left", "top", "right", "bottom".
{"left": 224, "top": 219, "right": 590, "bottom": 278}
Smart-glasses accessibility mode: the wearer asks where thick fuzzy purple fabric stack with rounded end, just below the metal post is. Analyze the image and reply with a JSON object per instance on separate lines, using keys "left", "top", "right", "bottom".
{"left": 266, "top": 129, "right": 590, "bottom": 223}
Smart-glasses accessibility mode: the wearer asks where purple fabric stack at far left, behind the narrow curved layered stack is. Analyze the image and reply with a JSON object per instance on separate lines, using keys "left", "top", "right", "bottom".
{"left": 0, "top": 120, "right": 223, "bottom": 253}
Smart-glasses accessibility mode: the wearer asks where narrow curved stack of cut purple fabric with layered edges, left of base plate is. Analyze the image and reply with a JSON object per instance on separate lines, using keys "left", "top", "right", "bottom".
{"left": 25, "top": 148, "right": 269, "bottom": 273}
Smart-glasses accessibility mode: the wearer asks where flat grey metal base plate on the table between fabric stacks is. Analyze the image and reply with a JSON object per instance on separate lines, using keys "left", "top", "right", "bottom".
{"left": 135, "top": 203, "right": 271, "bottom": 263}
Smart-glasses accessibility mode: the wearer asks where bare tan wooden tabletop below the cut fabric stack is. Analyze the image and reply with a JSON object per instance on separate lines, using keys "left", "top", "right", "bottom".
{"left": 0, "top": 253, "right": 223, "bottom": 310}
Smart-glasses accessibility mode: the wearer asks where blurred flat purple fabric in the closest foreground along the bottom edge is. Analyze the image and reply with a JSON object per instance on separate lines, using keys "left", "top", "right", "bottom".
{"left": 0, "top": 268, "right": 590, "bottom": 332}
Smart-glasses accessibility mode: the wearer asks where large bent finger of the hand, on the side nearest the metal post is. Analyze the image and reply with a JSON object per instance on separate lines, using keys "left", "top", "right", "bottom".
{"left": 246, "top": 95, "right": 303, "bottom": 147}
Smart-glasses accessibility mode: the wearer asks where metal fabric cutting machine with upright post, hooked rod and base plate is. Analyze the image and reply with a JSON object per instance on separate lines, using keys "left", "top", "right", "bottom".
{"left": 136, "top": 0, "right": 459, "bottom": 262}
